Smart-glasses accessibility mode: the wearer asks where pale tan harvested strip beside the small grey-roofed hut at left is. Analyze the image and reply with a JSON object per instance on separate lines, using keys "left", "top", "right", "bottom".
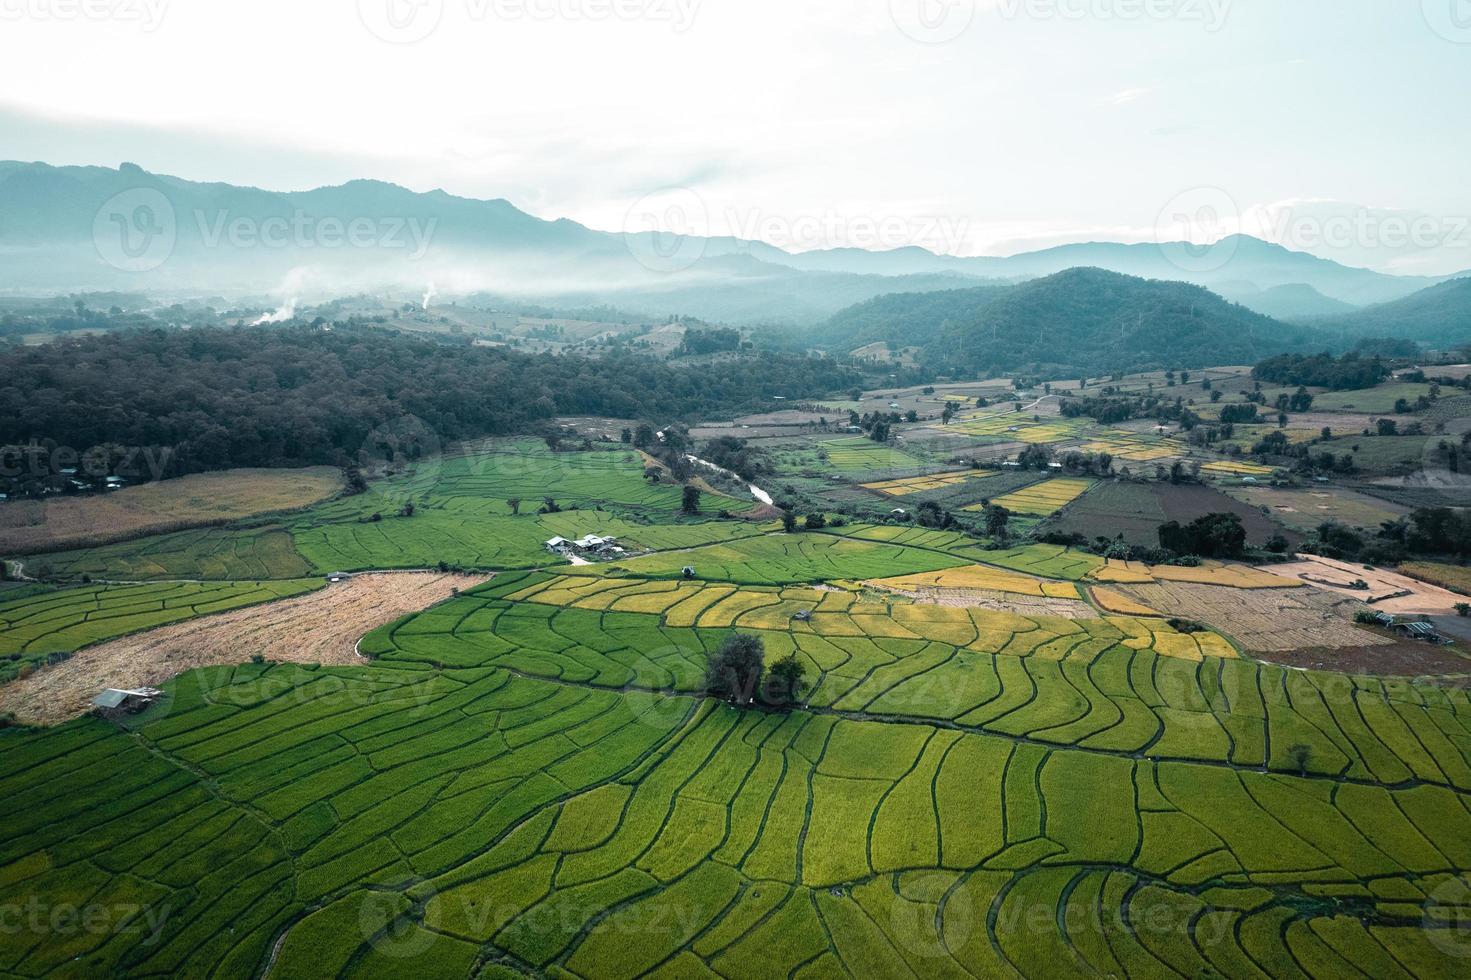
{"left": 0, "top": 572, "right": 488, "bottom": 725}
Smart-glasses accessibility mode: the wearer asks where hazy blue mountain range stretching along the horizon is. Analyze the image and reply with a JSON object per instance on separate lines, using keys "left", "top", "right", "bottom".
{"left": 0, "top": 162, "right": 1465, "bottom": 332}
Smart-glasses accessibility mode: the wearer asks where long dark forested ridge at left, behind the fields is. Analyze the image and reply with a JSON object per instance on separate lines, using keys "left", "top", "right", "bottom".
{"left": 0, "top": 325, "right": 866, "bottom": 475}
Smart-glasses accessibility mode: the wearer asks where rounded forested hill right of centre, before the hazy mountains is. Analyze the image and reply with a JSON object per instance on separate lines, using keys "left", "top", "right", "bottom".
{"left": 825, "top": 269, "right": 1330, "bottom": 377}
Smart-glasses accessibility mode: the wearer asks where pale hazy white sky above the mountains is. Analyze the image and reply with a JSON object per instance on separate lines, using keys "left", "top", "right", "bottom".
{"left": 0, "top": 0, "right": 1471, "bottom": 274}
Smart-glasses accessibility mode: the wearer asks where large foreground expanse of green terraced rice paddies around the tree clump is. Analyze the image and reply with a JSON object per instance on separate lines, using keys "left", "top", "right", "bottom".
{"left": 0, "top": 574, "right": 1471, "bottom": 979}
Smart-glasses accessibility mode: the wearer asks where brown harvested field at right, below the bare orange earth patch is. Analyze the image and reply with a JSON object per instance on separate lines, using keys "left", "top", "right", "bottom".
{"left": 1115, "top": 581, "right": 1392, "bottom": 653}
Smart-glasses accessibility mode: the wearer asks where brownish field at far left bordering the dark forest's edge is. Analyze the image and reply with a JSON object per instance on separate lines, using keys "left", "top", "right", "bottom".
{"left": 0, "top": 466, "right": 343, "bottom": 555}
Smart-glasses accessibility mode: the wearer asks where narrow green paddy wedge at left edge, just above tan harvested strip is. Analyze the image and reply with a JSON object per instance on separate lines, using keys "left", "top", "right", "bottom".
{"left": 0, "top": 578, "right": 325, "bottom": 681}
